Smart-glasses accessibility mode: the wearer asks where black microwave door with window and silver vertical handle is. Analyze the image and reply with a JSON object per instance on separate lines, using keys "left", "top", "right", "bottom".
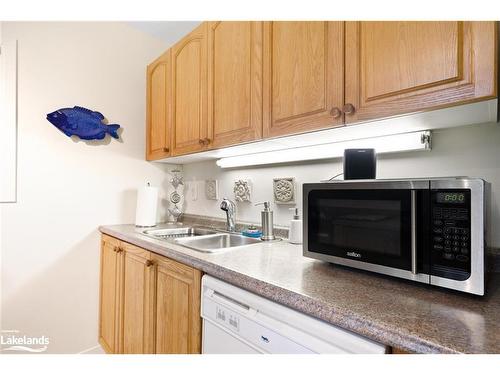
{"left": 307, "top": 189, "right": 426, "bottom": 279}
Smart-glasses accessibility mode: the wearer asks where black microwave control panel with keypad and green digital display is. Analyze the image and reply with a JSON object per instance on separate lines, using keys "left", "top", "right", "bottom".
{"left": 430, "top": 189, "right": 471, "bottom": 280}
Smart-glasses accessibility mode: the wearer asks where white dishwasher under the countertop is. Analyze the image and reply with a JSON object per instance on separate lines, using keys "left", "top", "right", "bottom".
{"left": 201, "top": 275, "right": 386, "bottom": 354}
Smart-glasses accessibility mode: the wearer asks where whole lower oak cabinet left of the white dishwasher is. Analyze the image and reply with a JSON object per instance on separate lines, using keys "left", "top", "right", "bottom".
{"left": 99, "top": 235, "right": 202, "bottom": 354}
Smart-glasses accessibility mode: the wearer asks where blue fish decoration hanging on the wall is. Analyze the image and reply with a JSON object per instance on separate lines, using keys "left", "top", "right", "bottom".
{"left": 47, "top": 106, "right": 120, "bottom": 140}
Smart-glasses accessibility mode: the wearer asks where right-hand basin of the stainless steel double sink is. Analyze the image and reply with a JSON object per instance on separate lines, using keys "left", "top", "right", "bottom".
{"left": 175, "top": 233, "right": 261, "bottom": 253}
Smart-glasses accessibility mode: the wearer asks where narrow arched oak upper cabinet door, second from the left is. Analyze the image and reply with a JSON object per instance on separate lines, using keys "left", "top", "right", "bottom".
{"left": 172, "top": 22, "right": 210, "bottom": 155}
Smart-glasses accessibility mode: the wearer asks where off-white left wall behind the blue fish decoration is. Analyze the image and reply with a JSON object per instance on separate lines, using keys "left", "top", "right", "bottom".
{"left": 0, "top": 22, "right": 175, "bottom": 353}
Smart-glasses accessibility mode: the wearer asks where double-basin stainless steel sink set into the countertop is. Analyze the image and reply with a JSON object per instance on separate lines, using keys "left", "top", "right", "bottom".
{"left": 143, "top": 227, "right": 261, "bottom": 253}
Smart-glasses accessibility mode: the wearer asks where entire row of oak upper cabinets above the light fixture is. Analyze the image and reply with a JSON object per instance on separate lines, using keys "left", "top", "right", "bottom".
{"left": 147, "top": 21, "right": 498, "bottom": 160}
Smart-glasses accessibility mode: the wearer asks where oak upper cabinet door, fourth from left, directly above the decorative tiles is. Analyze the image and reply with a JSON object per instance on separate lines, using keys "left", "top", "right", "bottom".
{"left": 264, "top": 21, "right": 344, "bottom": 137}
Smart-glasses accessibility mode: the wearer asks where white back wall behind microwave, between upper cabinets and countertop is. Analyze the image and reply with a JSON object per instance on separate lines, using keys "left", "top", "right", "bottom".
{"left": 184, "top": 124, "right": 500, "bottom": 247}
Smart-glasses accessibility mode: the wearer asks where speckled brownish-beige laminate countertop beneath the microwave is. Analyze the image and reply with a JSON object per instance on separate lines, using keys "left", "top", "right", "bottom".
{"left": 99, "top": 225, "right": 500, "bottom": 353}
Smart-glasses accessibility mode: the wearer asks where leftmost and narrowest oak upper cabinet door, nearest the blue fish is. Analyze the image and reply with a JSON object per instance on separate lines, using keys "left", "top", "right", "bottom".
{"left": 146, "top": 50, "right": 172, "bottom": 160}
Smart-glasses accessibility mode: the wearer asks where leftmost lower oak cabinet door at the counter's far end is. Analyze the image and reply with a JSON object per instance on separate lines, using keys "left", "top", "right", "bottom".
{"left": 99, "top": 235, "right": 123, "bottom": 353}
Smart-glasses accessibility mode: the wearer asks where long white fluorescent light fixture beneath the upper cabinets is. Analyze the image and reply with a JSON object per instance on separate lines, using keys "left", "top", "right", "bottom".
{"left": 216, "top": 130, "right": 431, "bottom": 168}
